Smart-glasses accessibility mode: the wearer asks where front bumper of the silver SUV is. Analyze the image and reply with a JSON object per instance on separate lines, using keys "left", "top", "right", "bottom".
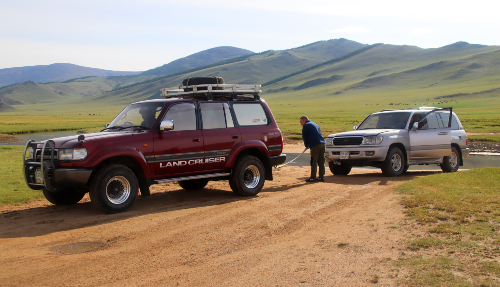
{"left": 325, "top": 146, "right": 389, "bottom": 161}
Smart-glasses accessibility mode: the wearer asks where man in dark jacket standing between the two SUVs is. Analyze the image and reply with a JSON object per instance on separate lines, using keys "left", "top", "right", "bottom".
{"left": 300, "top": 116, "right": 325, "bottom": 182}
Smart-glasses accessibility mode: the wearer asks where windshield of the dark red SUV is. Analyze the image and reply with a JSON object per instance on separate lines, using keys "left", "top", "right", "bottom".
{"left": 106, "top": 103, "right": 164, "bottom": 130}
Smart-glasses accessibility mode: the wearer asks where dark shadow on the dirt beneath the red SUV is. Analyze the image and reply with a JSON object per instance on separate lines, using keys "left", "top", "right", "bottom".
{"left": 0, "top": 184, "right": 301, "bottom": 238}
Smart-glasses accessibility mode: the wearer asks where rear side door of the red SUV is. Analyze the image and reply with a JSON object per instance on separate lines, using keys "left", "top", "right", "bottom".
{"left": 200, "top": 102, "right": 241, "bottom": 170}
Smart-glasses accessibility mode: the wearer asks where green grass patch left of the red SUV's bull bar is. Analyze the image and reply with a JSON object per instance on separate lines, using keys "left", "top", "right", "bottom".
{"left": 0, "top": 145, "right": 43, "bottom": 206}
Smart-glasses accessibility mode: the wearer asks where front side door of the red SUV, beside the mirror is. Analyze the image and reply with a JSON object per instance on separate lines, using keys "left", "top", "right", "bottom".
{"left": 154, "top": 102, "right": 204, "bottom": 177}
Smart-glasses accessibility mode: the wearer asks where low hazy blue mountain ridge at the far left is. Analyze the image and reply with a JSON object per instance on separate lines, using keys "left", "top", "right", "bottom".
{"left": 0, "top": 64, "right": 140, "bottom": 87}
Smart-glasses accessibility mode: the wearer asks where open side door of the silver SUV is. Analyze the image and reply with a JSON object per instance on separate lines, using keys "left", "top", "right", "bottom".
{"left": 409, "top": 110, "right": 451, "bottom": 160}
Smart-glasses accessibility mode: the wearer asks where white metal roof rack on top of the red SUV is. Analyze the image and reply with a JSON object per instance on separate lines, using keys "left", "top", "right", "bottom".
{"left": 161, "top": 84, "right": 262, "bottom": 98}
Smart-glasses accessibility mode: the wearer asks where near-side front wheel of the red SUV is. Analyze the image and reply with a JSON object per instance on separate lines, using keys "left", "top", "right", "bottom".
{"left": 89, "top": 164, "right": 139, "bottom": 213}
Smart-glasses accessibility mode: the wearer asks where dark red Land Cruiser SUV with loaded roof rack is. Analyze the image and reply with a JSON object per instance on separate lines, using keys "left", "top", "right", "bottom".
{"left": 23, "top": 77, "right": 286, "bottom": 212}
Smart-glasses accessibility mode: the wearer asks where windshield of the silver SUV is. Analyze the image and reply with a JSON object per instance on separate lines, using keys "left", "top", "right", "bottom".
{"left": 358, "top": 111, "right": 411, "bottom": 130}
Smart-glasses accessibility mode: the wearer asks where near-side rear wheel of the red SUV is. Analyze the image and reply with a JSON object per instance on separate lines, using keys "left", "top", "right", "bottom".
{"left": 229, "top": 155, "right": 266, "bottom": 196}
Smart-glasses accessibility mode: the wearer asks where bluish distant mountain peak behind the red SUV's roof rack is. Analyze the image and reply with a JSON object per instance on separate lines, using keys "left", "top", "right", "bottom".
{"left": 141, "top": 46, "right": 253, "bottom": 76}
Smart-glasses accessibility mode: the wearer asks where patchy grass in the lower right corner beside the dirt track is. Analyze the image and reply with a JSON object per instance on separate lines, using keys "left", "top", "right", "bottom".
{"left": 398, "top": 168, "right": 500, "bottom": 286}
